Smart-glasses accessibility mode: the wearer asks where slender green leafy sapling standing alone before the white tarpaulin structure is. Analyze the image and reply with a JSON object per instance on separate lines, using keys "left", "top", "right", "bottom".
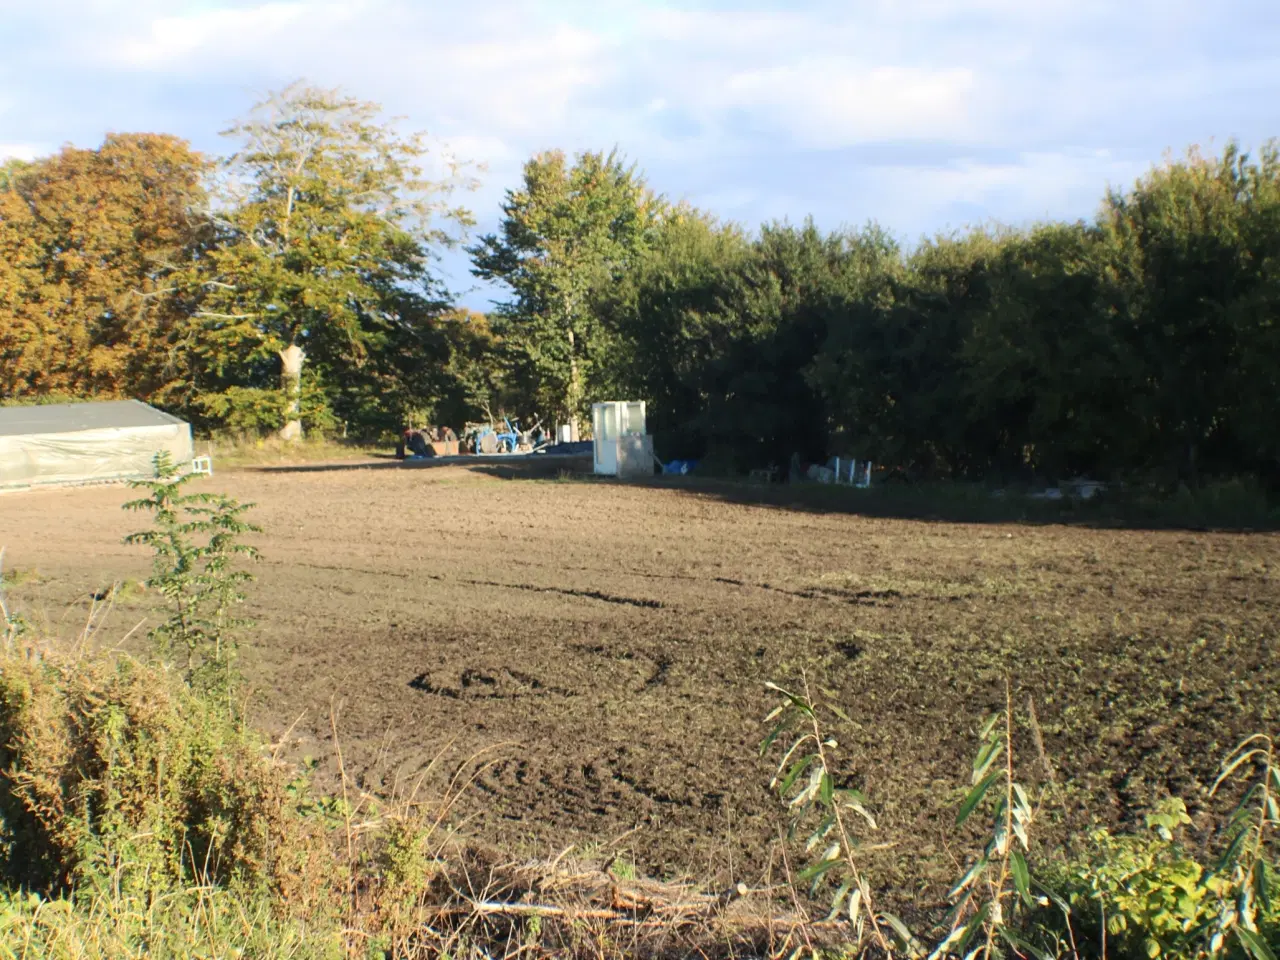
{"left": 124, "top": 452, "right": 259, "bottom": 692}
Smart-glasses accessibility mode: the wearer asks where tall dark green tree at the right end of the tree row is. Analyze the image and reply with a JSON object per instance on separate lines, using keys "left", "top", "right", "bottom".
{"left": 1102, "top": 142, "right": 1280, "bottom": 485}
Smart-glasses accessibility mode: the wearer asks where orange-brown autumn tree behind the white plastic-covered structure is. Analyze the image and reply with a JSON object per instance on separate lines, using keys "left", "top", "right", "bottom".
{"left": 0, "top": 133, "right": 207, "bottom": 403}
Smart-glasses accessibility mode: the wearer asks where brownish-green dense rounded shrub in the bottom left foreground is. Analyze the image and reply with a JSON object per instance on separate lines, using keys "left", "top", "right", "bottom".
{"left": 0, "top": 645, "right": 320, "bottom": 900}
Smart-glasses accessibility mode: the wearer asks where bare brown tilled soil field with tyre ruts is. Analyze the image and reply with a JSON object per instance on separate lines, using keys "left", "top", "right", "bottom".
{"left": 0, "top": 467, "right": 1280, "bottom": 911}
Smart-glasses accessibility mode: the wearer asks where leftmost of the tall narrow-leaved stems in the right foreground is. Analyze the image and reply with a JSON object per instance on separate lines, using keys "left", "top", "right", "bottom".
{"left": 760, "top": 681, "right": 922, "bottom": 956}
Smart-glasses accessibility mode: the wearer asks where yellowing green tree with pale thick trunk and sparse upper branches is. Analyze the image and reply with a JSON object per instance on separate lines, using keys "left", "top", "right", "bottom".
{"left": 192, "top": 83, "right": 474, "bottom": 439}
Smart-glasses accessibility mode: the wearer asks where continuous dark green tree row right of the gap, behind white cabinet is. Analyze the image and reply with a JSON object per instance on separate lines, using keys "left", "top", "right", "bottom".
{"left": 474, "top": 142, "right": 1280, "bottom": 486}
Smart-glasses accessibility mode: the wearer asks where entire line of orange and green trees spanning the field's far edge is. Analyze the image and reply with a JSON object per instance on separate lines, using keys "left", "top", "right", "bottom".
{"left": 0, "top": 84, "right": 1280, "bottom": 486}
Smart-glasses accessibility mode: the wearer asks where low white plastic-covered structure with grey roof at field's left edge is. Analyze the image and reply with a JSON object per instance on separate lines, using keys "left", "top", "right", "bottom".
{"left": 0, "top": 401, "right": 192, "bottom": 490}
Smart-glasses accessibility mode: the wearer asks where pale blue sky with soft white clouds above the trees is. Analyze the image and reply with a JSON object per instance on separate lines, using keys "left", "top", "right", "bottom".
{"left": 0, "top": 0, "right": 1280, "bottom": 308}
